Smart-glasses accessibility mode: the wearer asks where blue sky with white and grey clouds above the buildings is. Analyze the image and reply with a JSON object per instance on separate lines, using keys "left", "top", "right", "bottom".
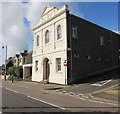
{"left": 0, "top": 0, "right": 118, "bottom": 63}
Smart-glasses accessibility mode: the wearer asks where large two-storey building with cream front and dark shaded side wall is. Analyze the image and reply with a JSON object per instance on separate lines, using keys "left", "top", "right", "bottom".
{"left": 32, "top": 5, "right": 120, "bottom": 85}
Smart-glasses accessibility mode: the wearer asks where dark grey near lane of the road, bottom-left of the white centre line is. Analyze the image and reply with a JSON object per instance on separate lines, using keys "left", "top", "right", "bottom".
{"left": 2, "top": 88, "right": 65, "bottom": 113}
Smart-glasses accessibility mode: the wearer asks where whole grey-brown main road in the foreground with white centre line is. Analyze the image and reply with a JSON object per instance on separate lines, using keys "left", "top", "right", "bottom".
{"left": 2, "top": 81, "right": 118, "bottom": 112}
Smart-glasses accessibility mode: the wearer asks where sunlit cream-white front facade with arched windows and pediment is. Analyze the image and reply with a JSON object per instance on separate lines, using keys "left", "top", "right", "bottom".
{"left": 32, "top": 5, "right": 68, "bottom": 84}
